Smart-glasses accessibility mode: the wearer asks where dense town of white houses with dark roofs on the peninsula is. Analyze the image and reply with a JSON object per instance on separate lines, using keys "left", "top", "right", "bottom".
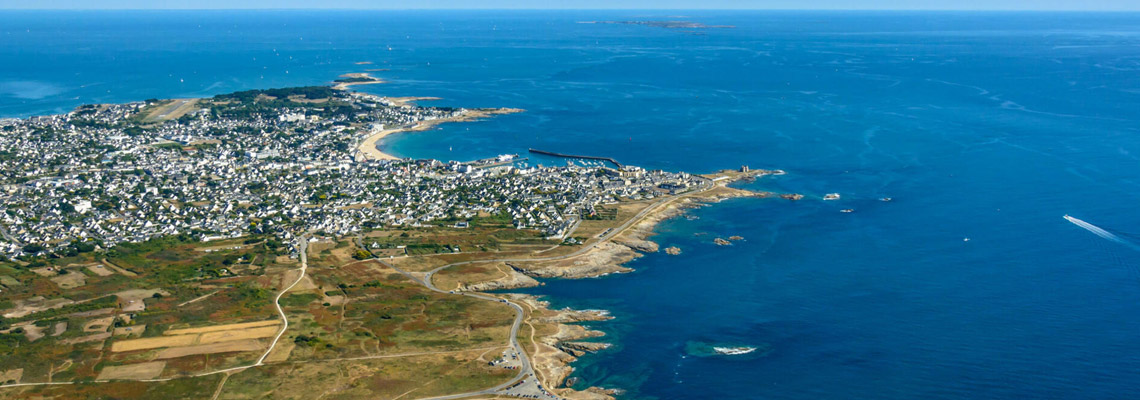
{"left": 0, "top": 90, "right": 707, "bottom": 256}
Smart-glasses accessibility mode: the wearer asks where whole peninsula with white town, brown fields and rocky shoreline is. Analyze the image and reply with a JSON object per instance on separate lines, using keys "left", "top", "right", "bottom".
{"left": 0, "top": 82, "right": 798, "bottom": 399}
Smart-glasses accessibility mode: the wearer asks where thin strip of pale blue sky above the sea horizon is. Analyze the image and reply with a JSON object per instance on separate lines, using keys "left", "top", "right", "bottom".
{"left": 0, "top": 0, "right": 1140, "bottom": 11}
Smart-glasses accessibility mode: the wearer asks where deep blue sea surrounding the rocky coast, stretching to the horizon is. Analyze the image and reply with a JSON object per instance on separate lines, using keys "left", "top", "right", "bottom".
{"left": 0, "top": 11, "right": 1140, "bottom": 399}
